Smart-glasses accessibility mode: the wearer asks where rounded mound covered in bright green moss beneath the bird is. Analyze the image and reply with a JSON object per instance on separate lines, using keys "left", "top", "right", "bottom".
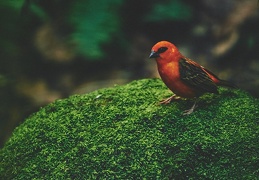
{"left": 0, "top": 79, "right": 259, "bottom": 179}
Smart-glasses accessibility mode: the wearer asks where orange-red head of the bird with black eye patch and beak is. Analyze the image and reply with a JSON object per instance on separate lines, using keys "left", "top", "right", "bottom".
{"left": 149, "top": 41, "right": 181, "bottom": 61}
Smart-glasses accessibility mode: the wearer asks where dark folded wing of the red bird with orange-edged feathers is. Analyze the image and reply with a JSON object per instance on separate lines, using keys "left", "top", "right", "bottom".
{"left": 179, "top": 58, "right": 218, "bottom": 94}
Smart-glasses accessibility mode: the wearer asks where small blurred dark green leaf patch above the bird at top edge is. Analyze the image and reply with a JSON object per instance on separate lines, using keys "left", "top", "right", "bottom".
{"left": 144, "top": 0, "right": 193, "bottom": 22}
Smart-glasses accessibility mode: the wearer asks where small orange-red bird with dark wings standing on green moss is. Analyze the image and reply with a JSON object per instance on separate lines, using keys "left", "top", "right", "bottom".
{"left": 149, "top": 41, "right": 236, "bottom": 115}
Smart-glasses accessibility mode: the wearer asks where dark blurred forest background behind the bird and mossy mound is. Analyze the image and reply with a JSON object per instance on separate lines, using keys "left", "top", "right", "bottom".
{"left": 0, "top": 0, "right": 259, "bottom": 147}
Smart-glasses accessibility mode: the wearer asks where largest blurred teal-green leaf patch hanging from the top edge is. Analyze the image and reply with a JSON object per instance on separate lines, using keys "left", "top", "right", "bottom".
{"left": 69, "top": 0, "right": 123, "bottom": 59}
